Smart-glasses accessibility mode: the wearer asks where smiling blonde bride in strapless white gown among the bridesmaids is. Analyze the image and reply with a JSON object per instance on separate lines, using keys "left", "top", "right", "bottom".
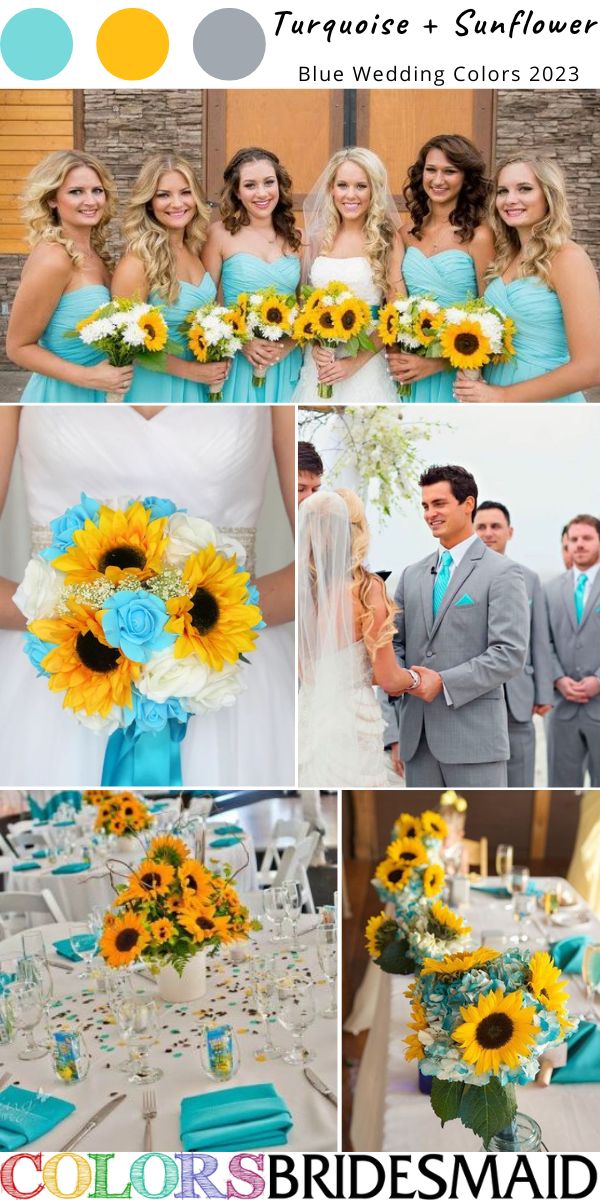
{"left": 294, "top": 146, "right": 404, "bottom": 404}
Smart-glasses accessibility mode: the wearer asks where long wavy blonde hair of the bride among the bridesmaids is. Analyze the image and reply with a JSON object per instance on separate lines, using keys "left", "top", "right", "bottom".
{"left": 319, "top": 146, "right": 396, "bottom": 292}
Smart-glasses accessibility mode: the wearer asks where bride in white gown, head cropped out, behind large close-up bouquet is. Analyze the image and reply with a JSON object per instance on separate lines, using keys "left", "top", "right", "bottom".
{"left": 0, "top": 404, "right": 295, "bottom": 788}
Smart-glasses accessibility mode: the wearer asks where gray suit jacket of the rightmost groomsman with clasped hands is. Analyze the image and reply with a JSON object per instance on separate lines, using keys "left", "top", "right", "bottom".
{"left": 546, "top": 571, "right": 600, "bottom": 721}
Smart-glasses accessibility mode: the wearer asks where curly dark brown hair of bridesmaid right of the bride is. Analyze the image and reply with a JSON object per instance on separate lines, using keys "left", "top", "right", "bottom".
{"left": 402, "top": 133, "right": 490, "bottom": 242}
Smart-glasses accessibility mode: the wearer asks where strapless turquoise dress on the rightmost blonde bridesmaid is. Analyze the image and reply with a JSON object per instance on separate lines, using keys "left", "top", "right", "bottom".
{"left": 484, "top": 275, "right": 586, "bottom": 404}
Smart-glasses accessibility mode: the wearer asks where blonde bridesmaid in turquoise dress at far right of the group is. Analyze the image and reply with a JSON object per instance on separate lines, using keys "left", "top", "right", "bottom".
{"left": 456, "top": 157, "right": 600, "bottom": 404}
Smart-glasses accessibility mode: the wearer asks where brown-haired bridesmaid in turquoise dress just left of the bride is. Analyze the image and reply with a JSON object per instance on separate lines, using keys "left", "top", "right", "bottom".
{"left": 202, "top": 146, "right": 302, "bottom": 404}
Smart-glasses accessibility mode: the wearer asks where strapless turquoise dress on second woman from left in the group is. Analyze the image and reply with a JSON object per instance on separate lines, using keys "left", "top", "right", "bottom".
{"left": 124, "top": 271, "right": 217, "bottom": 404}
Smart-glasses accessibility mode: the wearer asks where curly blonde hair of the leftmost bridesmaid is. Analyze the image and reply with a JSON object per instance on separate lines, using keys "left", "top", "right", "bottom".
{"left": 23, "top": 150, "right": 116, "bottom": 266}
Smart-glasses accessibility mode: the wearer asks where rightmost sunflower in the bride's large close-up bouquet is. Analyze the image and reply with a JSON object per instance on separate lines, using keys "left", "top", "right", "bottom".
{"left": 164, "top": 546, "right": 260, "bottom": 671}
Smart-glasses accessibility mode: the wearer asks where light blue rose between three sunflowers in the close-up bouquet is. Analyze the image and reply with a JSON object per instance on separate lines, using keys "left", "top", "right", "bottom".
{"left": 102, "top": 590, "right": 175, "bottom": 662}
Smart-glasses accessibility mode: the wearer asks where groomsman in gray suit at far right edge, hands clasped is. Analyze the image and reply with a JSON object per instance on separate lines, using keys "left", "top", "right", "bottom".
{"left": 546, "top": 512, "right": 600, "bottom": 787}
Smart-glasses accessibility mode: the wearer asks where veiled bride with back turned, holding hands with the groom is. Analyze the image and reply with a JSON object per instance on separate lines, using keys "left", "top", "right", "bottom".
{"left": 298, "top": 488, "right": 418, "bottom": 787}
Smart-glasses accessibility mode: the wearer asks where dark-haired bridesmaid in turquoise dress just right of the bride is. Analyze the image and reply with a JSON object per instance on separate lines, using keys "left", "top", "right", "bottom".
{"left": 388, "top": 133, "right": 493, "bottom": 404}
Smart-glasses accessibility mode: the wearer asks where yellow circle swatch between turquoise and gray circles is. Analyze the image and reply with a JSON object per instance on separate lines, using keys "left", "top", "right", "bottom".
{"left": 96, "top": 8, "right": 169, "bottom": 79}
